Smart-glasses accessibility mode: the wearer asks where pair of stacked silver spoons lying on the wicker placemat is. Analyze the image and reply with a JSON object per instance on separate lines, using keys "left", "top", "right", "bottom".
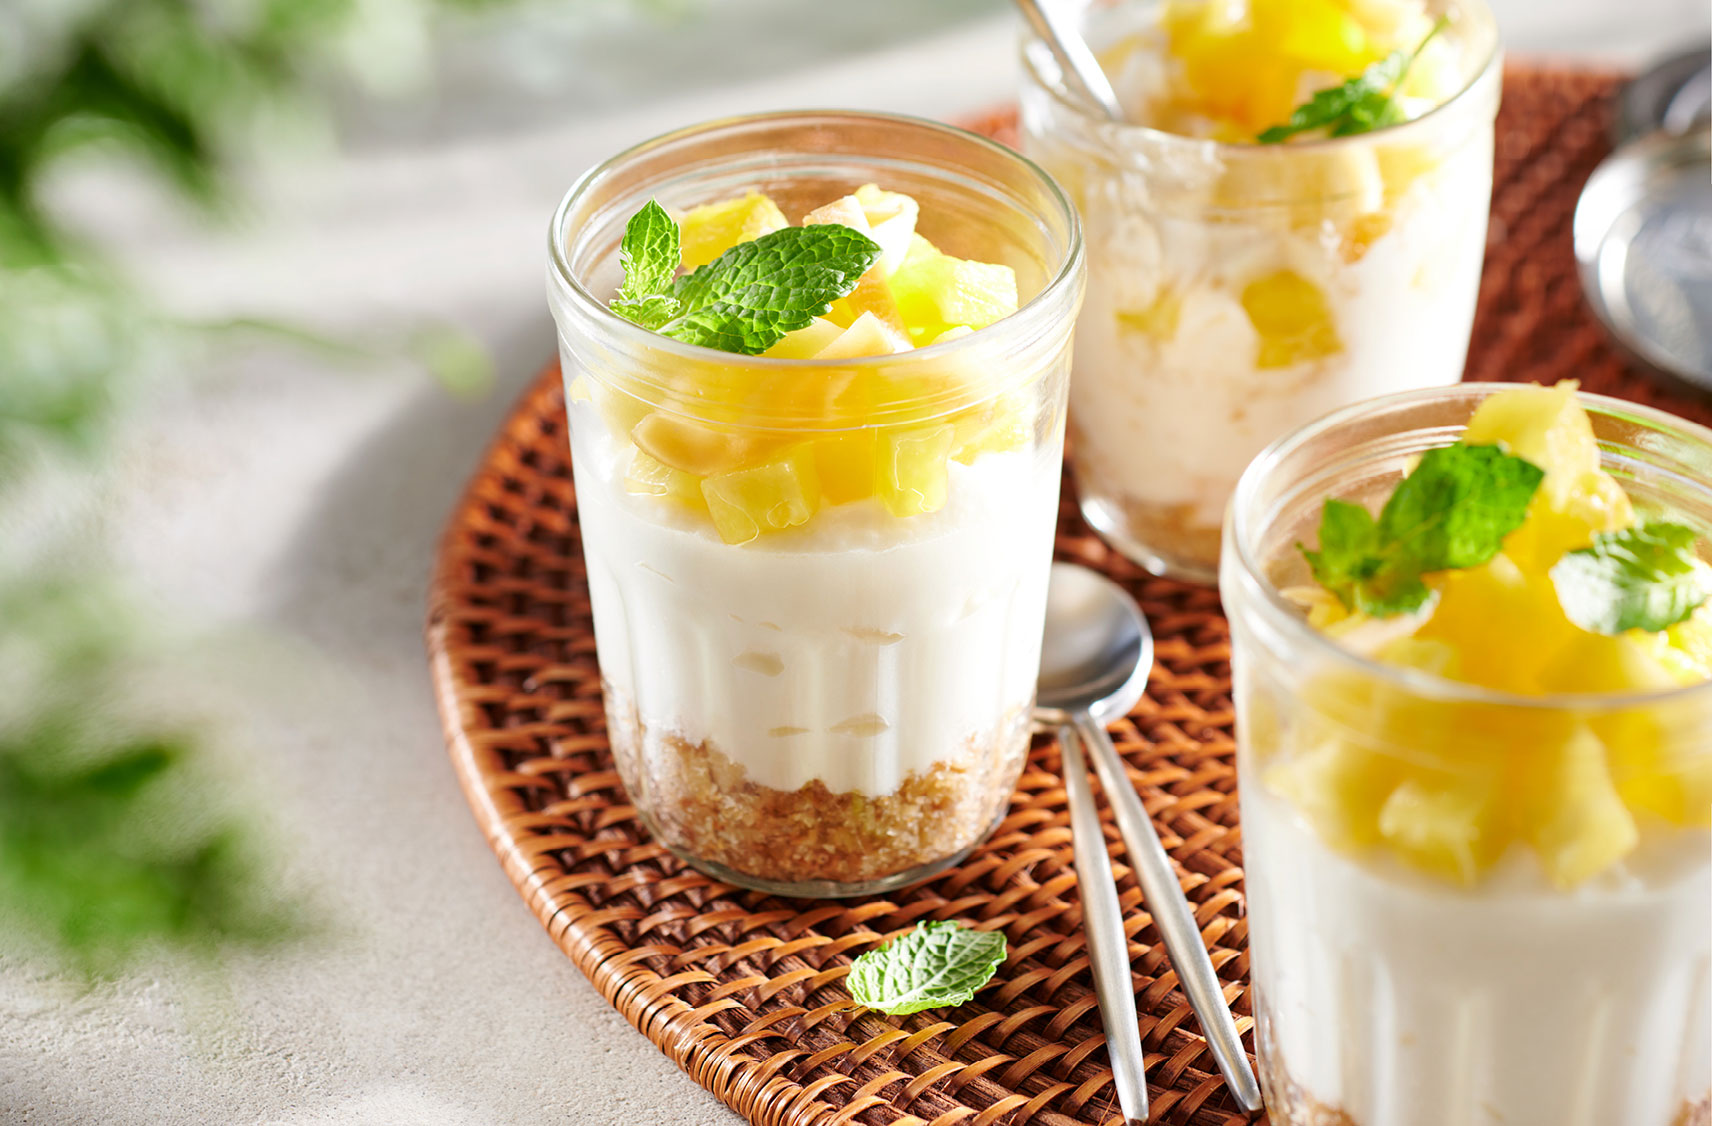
{"left": 1034, "top": 563, "right": 1262, "bottom": 1117}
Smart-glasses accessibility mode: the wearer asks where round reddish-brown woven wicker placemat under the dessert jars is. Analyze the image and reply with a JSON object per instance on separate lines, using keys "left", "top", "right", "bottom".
{"left": 428, "top": 67, "right": 1684, "bottom": 1126}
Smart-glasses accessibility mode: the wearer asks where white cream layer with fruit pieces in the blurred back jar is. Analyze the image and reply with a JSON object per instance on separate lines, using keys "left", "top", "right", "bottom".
{"left": 1070, "top": 153, "right": 1491, "bottom": 527}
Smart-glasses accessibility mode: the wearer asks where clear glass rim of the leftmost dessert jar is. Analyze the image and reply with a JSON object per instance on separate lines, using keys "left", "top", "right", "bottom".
{"left": 548, "top": 110, "right": 1084, "bottom": 371}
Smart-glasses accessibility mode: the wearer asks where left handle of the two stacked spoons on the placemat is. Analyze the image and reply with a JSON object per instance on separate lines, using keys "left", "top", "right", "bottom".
{"left": 1058, "top": 724, "right": 1147, "bottom": 1124}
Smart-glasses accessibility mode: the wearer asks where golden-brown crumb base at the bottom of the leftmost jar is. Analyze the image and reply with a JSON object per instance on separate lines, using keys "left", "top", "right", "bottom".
{"left": 608, "top": 691, "right": 1029, "bottom": 885}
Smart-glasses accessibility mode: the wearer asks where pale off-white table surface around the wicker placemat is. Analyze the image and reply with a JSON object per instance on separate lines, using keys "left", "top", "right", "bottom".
{"left": 0, "top": 0, "right": 1709, "bottom": 1126}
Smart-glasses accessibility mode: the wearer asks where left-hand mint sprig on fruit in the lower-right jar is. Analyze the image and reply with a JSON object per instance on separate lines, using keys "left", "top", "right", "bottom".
{"left": 1298, "top": 443, "right": 1546, "bottom": 618}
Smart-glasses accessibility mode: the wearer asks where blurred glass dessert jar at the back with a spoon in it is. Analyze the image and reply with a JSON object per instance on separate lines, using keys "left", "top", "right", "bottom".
{"left": 1022, "top": 0, "right": 1500, "bottom": 582}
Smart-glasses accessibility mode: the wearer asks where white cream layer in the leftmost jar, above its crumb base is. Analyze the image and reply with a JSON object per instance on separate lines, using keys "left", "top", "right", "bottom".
{"left": 572, "top": 402, "right": 1060, "bottom": 796}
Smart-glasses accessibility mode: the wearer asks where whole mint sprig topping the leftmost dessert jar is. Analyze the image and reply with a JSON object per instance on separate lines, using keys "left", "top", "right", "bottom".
{"left": 611, "top": 200, "right": 880, "bottom": 356}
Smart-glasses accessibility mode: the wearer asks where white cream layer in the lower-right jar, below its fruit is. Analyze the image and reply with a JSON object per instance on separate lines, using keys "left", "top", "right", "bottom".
{"left": 1243, "top": 779, "right": 1712, "bottom": 1126}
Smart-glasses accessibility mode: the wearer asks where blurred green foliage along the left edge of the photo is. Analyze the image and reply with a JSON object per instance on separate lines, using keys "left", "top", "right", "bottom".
{"left": 0, "top": 0, "right": 537, "bottom": 974}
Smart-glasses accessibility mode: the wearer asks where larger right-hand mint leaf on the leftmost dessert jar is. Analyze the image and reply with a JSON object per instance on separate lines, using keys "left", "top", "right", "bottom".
{"left": 659, "top": 222, "right": 880, "bottom": 356}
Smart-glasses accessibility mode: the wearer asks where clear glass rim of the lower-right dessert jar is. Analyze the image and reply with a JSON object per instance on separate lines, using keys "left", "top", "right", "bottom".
{"left": 1224, "top": 383, "right": 1712, "bottom": 714}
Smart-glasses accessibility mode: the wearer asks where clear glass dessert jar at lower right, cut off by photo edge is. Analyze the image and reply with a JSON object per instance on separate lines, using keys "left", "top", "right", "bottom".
{"left": 1221, "top": 385, "right": 1712, "bottom": 1126}
